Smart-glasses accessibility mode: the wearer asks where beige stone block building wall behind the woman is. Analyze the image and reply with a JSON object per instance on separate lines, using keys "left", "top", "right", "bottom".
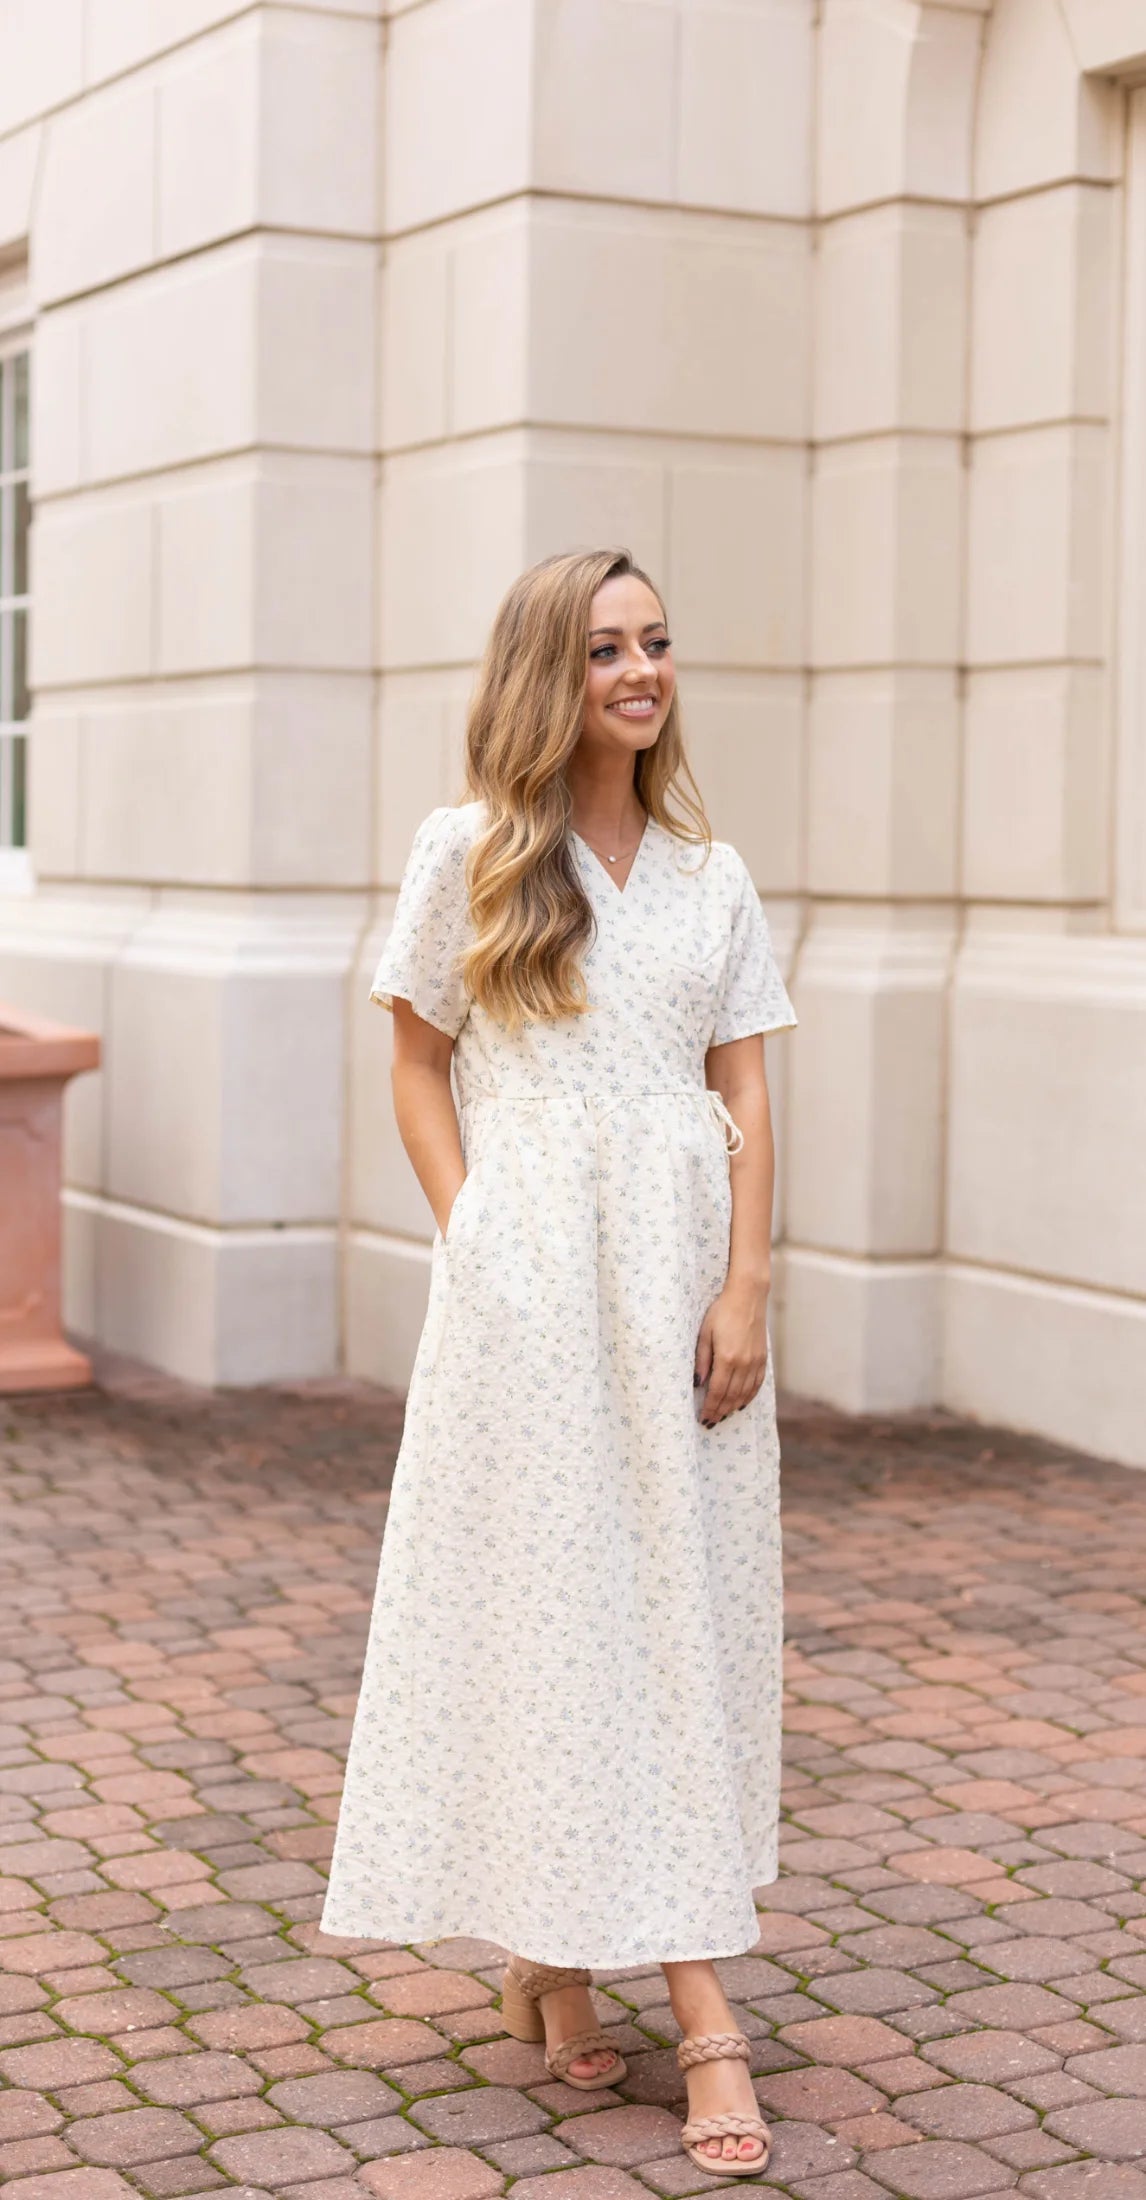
{"left": 0, "top": 0, "right": 1146, "bottom": 1463}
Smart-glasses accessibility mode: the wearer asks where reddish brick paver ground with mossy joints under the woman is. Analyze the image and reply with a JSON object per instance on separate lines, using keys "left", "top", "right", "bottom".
{"left": 0, "top": 1384, "right": 1146, "bottom": 2200}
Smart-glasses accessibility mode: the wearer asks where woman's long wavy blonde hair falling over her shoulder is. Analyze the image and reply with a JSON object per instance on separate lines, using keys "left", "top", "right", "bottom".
{"left": 462, "top": 550, "right": 713, "bottom": 1032}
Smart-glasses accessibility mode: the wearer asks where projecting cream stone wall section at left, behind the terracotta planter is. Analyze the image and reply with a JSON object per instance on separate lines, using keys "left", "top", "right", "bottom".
{"left": 0, "top": 0, "right": 383, "bottom": 1382}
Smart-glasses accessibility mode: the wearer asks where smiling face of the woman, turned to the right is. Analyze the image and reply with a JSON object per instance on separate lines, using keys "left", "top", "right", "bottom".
{"left": 581, "top": 574, "right": 677, "bottom": 757}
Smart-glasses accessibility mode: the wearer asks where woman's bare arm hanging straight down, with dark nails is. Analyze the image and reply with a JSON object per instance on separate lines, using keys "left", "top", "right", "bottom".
{"left": 695, "top": 1032, "right": 776, "bottom": 1428}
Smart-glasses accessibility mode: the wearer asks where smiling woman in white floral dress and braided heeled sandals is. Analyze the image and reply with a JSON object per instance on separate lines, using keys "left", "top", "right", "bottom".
{"left": 323, "top": 552, "right": 796, "bottom": 2176}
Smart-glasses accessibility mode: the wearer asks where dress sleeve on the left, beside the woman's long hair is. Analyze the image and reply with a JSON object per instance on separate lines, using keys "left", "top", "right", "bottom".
{"left": 370, "top": 810, "right": 471, "bottom": 1038}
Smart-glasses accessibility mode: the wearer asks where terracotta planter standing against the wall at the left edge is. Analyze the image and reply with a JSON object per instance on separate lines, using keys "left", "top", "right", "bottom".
{"left": 0, "top": 1001, "right": 99, "bottom": 1390}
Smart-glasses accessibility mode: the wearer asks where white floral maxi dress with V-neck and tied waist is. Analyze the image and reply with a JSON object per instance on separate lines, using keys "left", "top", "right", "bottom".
{"left": 321, "top": 803, "right": 796, "bottom": 1967}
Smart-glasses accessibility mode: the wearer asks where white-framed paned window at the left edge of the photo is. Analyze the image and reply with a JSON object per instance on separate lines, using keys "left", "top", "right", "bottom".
{"left": 0, "top": 339, "right": 29, "bottom": 849}
